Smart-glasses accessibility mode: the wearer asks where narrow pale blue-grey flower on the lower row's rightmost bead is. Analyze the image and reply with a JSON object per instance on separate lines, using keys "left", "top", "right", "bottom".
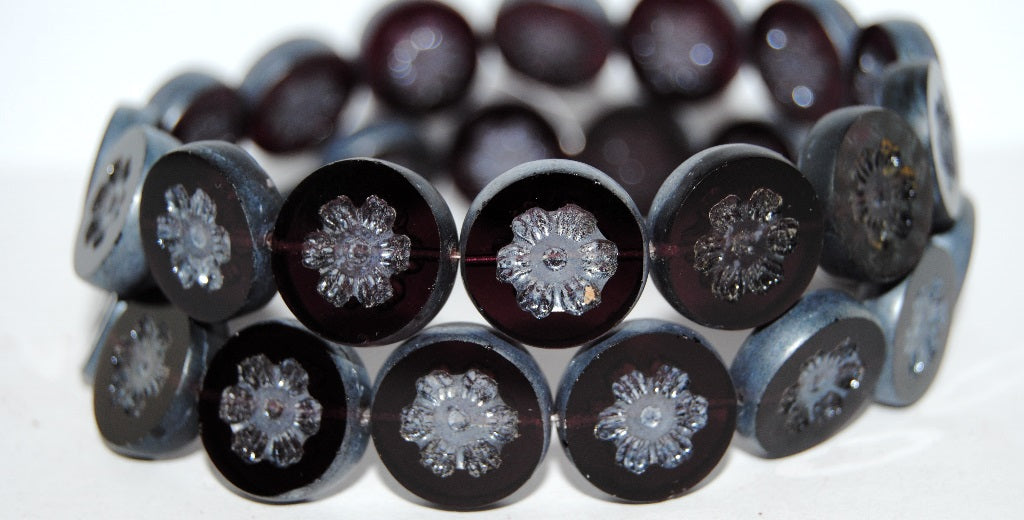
{"left": 903, "top": 278, "right": 949, "bottom": 376}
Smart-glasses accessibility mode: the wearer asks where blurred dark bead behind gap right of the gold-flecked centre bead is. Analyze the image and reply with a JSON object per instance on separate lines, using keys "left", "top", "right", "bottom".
{"left": 579, "top": 106, "right": 690, "bottom": 214}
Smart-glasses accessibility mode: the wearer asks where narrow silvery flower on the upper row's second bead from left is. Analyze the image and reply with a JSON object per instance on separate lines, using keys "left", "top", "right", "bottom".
{"left": 157, "top": 184, "right": 231, "bottom": 293}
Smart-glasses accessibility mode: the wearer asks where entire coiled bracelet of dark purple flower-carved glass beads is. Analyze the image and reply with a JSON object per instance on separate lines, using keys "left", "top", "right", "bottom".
{"left": 75, "top": 0, "right": 974, "bottom": 509}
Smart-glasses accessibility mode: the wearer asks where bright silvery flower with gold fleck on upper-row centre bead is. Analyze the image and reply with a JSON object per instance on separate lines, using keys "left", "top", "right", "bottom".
{"left": 498, "top": 204, "right": 618, "bottom": 318}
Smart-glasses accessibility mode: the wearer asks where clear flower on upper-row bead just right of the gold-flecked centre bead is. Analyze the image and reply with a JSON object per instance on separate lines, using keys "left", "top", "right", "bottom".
{"left": 693, "top": 187, "right": 799, "bottom": 302}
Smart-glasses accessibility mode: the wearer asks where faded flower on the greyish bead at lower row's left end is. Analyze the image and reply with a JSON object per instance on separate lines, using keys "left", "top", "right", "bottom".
{"left": 108, "top": 315, "right": 171, "bottom": 418}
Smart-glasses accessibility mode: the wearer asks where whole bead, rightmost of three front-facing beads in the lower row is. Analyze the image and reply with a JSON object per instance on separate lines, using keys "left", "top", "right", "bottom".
{"left": 555, "top": 319, "right": 736, "bottom": 502}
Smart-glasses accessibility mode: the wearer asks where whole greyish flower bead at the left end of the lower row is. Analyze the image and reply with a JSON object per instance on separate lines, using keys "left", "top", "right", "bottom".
{"left": 93, "top": 301, "right": 216, "bottom": 459}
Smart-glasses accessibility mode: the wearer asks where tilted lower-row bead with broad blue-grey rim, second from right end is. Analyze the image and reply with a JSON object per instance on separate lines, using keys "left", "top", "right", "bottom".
{"left": 729, "top": 291, "right": 886, "bottom": 458}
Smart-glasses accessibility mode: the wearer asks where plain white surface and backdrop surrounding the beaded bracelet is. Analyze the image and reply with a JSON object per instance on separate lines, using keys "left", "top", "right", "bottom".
{"left": 0, "top": 0, "right": 1024, "bottom": 518}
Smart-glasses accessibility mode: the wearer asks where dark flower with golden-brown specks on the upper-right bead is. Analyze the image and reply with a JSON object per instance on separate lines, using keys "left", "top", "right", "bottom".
{"left": 849, "top": 139, "right": 918, "bottom": 250}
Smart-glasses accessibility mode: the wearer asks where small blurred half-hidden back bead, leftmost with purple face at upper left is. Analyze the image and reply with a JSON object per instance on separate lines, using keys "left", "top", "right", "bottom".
{"left": 146, "top": 72, "right": 246, "bottom": 142}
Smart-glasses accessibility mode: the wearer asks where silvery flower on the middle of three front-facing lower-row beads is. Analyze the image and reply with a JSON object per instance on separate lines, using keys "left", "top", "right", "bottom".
{"left": 399, "top": 369, "right": 519, "bottom": 478}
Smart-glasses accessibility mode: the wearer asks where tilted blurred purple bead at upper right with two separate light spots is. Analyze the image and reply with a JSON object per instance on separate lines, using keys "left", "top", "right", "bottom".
{"left": 752, "top": 0, "right": 858, "bottom": 121}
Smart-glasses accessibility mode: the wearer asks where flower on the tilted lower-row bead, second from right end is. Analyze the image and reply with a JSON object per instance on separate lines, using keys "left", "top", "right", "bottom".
{"left": 778, "top": 338, "right": 864, "bottom": 433}
